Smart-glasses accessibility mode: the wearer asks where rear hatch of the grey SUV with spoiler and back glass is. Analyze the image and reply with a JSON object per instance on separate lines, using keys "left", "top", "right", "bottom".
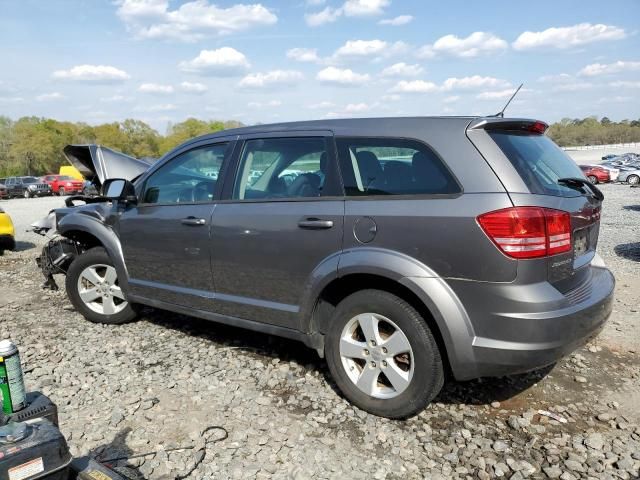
{"left": 469, "top": 119, "right": 603, "bottom": 293}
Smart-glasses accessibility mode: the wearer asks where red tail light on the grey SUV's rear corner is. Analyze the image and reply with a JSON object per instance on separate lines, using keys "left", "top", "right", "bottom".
{"left": 478, "top": 207, "right": 571, "bottom": 258}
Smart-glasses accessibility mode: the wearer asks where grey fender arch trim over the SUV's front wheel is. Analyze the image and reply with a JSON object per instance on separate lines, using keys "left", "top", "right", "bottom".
{"left": 57, "top": 212, "right": 129, "bottom": 295}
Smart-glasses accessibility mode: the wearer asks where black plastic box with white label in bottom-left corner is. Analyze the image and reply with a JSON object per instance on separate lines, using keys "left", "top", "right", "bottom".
{"left": 0, "top": 418, "right": 71, "bottom": 480}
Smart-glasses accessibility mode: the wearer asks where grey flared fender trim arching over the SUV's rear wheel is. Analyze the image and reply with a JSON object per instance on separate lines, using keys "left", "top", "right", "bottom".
{"left": 301, "top": 247, "right": 475, "bottom": 377}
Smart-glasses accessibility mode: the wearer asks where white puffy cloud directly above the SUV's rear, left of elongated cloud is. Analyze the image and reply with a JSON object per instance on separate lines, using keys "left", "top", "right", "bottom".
{"left": 417, "top": 32, "right": 509, "bottom": 58}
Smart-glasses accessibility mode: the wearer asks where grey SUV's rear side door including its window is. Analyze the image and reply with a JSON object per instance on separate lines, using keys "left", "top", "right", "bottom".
{"left": 211, "top": 134, "right": 344, "bottom": 328}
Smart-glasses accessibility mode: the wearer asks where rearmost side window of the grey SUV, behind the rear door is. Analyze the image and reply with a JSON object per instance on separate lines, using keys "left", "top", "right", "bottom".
{"left": 336, "top": 138, "right": 461, "bottom": 196}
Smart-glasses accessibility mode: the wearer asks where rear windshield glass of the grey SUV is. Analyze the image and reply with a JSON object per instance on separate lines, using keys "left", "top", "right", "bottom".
{"left": 489, "top": 132, "right": 584, "bottom": 197}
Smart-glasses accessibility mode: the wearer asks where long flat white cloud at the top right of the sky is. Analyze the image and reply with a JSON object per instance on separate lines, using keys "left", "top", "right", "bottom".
{"left": 513, "top": 23, "right": 626, "bottom": 50}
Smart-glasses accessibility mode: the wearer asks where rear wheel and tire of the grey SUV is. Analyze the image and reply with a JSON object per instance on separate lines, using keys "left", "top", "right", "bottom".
{"left": 325, "top": 290, "right": 444, "bottom": 418}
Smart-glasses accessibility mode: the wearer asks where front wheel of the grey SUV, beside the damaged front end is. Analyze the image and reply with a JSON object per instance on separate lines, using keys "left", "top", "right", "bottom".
{"left": 65, "top": 247, "right": 136, "bottom": 325}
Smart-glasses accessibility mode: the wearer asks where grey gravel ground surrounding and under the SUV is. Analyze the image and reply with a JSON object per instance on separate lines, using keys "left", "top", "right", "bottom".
{"left": 0, "top": 185, "right": 640, "bottom": 480}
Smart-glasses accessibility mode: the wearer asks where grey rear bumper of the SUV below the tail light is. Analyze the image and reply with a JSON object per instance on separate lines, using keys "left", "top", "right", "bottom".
{"left": 442, "top": 266, "right": 615, "bottom": 380}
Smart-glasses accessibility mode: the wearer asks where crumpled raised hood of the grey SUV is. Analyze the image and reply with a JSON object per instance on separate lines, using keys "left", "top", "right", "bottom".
{"left": 64, "top": 144, "right": 151, "bottom": 188}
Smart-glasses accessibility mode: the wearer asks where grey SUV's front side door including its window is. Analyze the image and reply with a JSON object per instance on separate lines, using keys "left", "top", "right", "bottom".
{"left": 119, "top": 142, "right": 230, "bottom": 310}
